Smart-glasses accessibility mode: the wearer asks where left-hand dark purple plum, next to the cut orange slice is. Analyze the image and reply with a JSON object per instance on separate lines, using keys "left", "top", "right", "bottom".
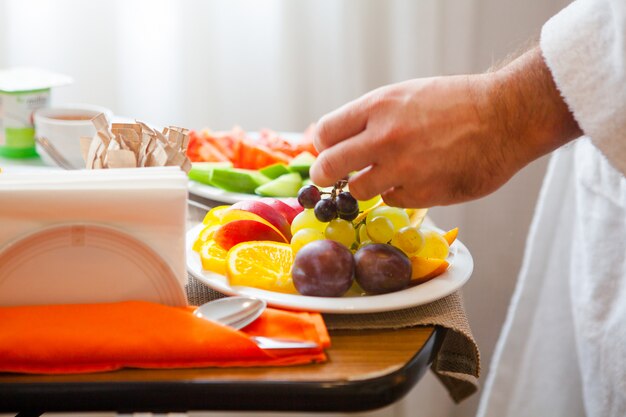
{"left": 291, "top": 239, "right": 354, "bottom": 297}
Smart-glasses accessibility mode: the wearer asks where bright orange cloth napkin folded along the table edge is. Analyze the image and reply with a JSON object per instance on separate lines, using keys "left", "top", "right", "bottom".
{"left": 0, "top": 301, "right": 330, "bottom": 374}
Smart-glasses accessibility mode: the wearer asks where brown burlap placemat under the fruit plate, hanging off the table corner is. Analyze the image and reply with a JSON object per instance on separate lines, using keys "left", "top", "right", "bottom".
{"left": 186, "top": 275, "right": 480, "bottom": 403}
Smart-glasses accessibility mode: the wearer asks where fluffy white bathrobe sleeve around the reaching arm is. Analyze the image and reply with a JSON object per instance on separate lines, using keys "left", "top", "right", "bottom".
{"left": 540, "top": 0, "right": 626, "bottom": 175}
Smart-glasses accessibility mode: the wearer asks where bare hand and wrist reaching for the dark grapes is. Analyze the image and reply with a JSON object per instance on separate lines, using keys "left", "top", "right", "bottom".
{"left": 311, "top": 48, "right": 579, "bottom": 207}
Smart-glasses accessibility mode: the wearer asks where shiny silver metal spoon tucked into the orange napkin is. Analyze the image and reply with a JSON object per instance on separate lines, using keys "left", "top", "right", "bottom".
{"left": 193, "top": 296, "right": 318, "bottom": 349}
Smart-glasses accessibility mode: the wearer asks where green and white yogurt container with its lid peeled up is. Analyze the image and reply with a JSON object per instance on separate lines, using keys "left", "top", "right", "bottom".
{"left": 0, "top": 68, "right": 72, "bottom": 158}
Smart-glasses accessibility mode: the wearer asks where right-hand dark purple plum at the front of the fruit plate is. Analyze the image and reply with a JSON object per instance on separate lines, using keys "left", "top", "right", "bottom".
{"left": 354, "top": 243, "right": 413, "bottom": 294}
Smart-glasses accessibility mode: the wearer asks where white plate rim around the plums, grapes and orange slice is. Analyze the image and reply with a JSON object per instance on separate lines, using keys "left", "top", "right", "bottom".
{"left": 187, "top": 224, "right": 474, "bottom": 314}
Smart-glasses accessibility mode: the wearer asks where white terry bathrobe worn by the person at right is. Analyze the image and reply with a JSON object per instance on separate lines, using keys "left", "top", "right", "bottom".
{"left": 478, "top": 0, "right": 626, "bottom": 417}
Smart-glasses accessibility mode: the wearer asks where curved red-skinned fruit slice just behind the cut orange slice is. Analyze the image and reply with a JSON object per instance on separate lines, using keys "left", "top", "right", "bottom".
{"left": 213, "top": 219, "right": 289, "bottom": 250}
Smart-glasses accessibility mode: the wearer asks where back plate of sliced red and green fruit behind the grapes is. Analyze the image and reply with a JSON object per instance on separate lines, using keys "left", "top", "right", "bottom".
{"left": 188, "top": 129, "right": 315, "bottom": 203}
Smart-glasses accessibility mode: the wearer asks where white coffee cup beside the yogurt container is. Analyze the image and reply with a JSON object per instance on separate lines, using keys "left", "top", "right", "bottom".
{"left": 34, "top": 104, "right": 113, "bottom": 168}
